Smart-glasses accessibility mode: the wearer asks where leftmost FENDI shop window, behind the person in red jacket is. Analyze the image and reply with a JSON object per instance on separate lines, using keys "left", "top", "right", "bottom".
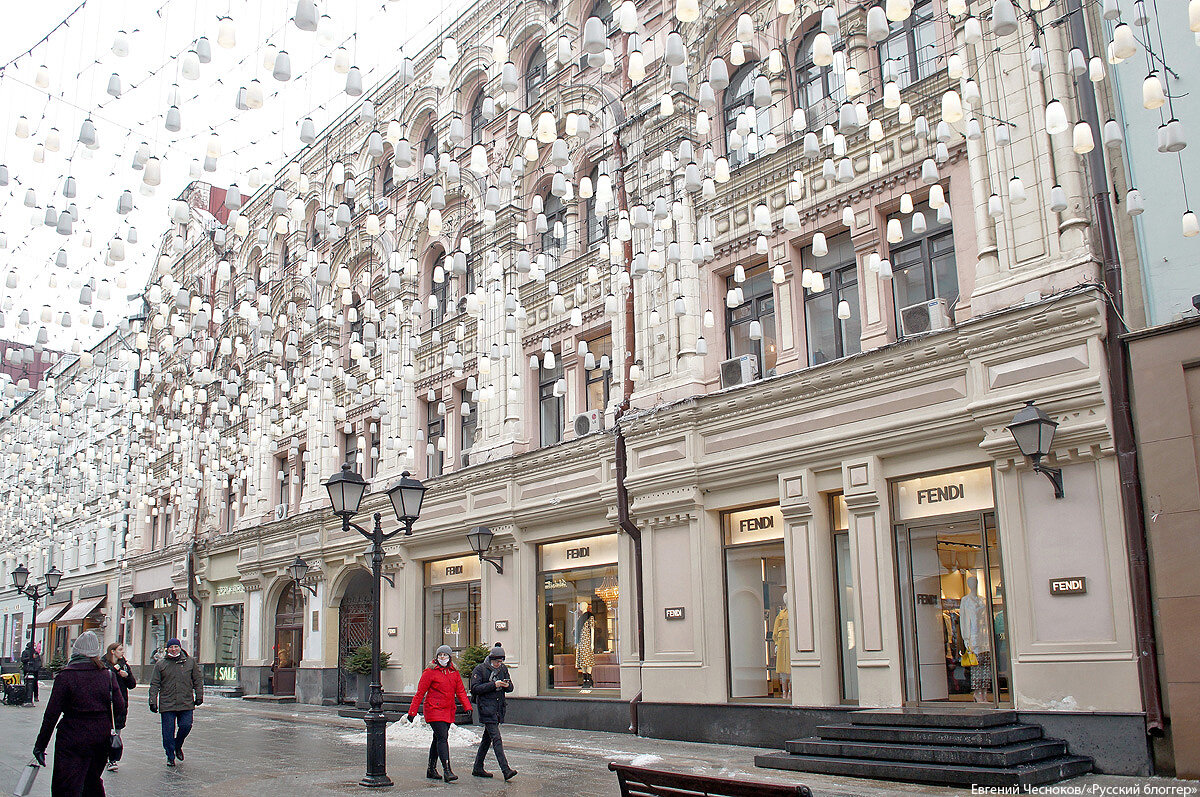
{"left": 425, "top": 556, "right": 480, "bottom": 657}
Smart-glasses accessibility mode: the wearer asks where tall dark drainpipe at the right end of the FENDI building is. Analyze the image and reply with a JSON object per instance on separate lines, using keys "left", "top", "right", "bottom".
{"left": 1067, "top": 0, "right": 1164, "bottom": 735}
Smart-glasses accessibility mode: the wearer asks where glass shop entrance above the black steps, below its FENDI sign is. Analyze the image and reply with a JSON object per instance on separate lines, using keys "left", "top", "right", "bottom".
{"left": 895, "top": 511, "right": 1012, "bottom": 706}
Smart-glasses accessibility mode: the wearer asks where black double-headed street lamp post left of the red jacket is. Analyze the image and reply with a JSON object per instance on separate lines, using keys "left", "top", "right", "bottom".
{"left": 324, "top": 462, "right": 426, "bottom": 787}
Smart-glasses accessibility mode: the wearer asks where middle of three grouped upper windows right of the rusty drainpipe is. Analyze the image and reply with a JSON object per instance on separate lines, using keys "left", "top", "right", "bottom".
{"left": 804, "top": 235, "right": 863, "bottom": 365}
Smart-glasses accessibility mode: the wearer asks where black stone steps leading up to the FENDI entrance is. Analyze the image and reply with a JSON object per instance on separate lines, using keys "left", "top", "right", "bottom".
{"left": 755, "top": 708, "right": 1092, "bottom": 787}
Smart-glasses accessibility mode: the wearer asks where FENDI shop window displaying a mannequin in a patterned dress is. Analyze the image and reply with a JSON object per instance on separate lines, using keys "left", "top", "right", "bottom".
{"left": 539, "top": 534, "right": 620, "bottom": 694}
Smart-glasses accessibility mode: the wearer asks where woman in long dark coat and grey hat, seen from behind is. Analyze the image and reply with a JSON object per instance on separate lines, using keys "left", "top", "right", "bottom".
{"left": 34, "top": 631, "right": 126, "bottom": 797}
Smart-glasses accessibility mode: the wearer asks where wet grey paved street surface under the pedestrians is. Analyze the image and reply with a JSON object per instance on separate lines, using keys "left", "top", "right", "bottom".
{"left": 0, "top": 684, "right": 1196, "bottom": 797}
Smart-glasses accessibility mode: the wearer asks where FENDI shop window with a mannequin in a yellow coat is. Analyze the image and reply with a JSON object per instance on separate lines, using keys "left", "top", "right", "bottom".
{"left": 725, "top": 505, "right": 792, "bottom": 700}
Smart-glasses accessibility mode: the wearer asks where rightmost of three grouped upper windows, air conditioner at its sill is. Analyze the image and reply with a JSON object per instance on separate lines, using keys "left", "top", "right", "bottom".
{"left": 890, "top": 205, "right": 959, "bottom": 328}
